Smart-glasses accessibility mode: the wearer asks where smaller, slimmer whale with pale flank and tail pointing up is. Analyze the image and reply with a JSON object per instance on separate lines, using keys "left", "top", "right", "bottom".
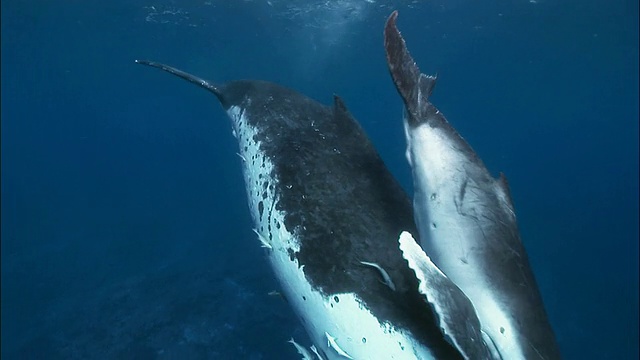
{"left": 384, "top": 12, "right": 560, "bottom": 360}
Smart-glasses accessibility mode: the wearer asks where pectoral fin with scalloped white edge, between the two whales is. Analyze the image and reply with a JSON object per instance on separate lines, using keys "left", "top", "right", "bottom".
{"left": 399, "top": 231, "right": 490, "bottom": 359}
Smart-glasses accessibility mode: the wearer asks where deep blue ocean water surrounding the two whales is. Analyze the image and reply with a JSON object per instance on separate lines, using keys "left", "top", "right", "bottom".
{"left": 1, "top": 0, "right": 639, "bottom": 359}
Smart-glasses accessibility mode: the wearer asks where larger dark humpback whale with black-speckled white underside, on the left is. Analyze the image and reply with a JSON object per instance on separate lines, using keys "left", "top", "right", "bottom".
{"left": 137, "top": 61, "right": 482, "bottom": 359}
